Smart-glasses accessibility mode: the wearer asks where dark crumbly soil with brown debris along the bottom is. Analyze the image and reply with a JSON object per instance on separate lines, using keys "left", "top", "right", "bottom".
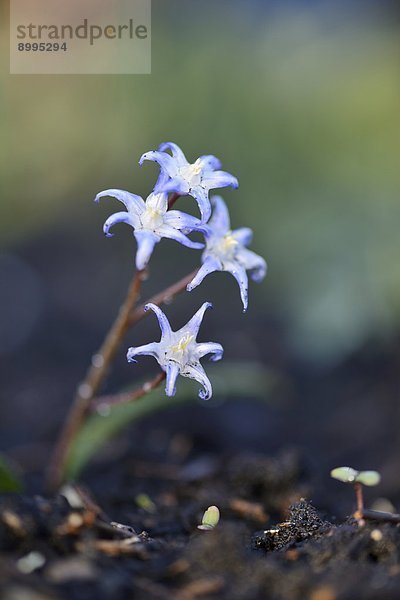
{"left": 0, "top": 448, "right": 400, "bottom": 600}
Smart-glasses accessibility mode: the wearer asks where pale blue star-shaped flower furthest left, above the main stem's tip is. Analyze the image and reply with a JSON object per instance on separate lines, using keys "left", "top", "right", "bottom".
{"left": 95, "top": 190, "right": 204, "bottom": 270}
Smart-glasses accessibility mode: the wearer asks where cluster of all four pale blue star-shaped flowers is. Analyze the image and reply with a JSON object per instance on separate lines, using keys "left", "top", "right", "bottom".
{"left": 95, "top": 142, "right": 267, "bottom": 400}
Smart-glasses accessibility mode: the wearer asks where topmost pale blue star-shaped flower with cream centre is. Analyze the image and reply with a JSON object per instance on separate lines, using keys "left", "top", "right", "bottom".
{"left": 139, "top": 142, "right": 239, "bottom": 223}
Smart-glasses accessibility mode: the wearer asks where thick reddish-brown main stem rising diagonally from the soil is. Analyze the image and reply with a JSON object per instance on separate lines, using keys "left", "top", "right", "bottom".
{"left": 47, "top": 270, "right": 146, "bottom": 489}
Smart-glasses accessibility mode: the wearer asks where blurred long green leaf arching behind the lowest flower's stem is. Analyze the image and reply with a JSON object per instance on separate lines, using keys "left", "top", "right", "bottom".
{"left": 65, "top": 362, "right": 278, "bottom": 480}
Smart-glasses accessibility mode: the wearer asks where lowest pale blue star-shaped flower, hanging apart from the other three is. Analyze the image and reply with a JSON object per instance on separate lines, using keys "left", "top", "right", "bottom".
{"left": 127, "top": 302, "right": 224, "bottom": 400}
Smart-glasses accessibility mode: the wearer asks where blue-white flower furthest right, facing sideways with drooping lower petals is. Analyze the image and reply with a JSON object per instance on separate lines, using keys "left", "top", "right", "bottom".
{"left": 186, "top": 196, "right": 267, "bottom": 312}
